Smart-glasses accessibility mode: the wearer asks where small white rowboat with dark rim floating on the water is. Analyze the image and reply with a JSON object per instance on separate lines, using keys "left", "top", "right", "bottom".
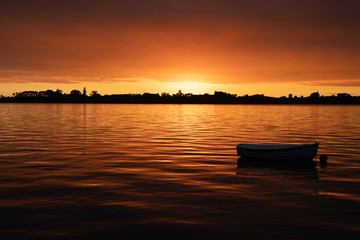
{"left": 236, "top": 142, "right": 319, "bottom": 160}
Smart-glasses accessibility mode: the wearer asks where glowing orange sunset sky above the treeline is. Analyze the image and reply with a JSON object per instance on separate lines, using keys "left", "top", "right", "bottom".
{"left": 0, "top": 0, "right": 360, "bottom": 97}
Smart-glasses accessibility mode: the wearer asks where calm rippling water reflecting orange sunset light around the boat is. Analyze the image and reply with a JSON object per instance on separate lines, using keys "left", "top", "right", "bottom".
{"left": 0, "top": 104, "right": 360, "bottom": 239}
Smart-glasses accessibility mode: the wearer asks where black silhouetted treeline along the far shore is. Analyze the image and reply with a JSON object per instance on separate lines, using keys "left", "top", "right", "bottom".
{"left": 0, "top": 88, "right": 360, "bottom": 104}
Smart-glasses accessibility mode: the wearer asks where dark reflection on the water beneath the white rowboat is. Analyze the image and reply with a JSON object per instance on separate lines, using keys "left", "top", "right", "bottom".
{"left": 236, "top": 157, "right": 317, "bottom": 176}
